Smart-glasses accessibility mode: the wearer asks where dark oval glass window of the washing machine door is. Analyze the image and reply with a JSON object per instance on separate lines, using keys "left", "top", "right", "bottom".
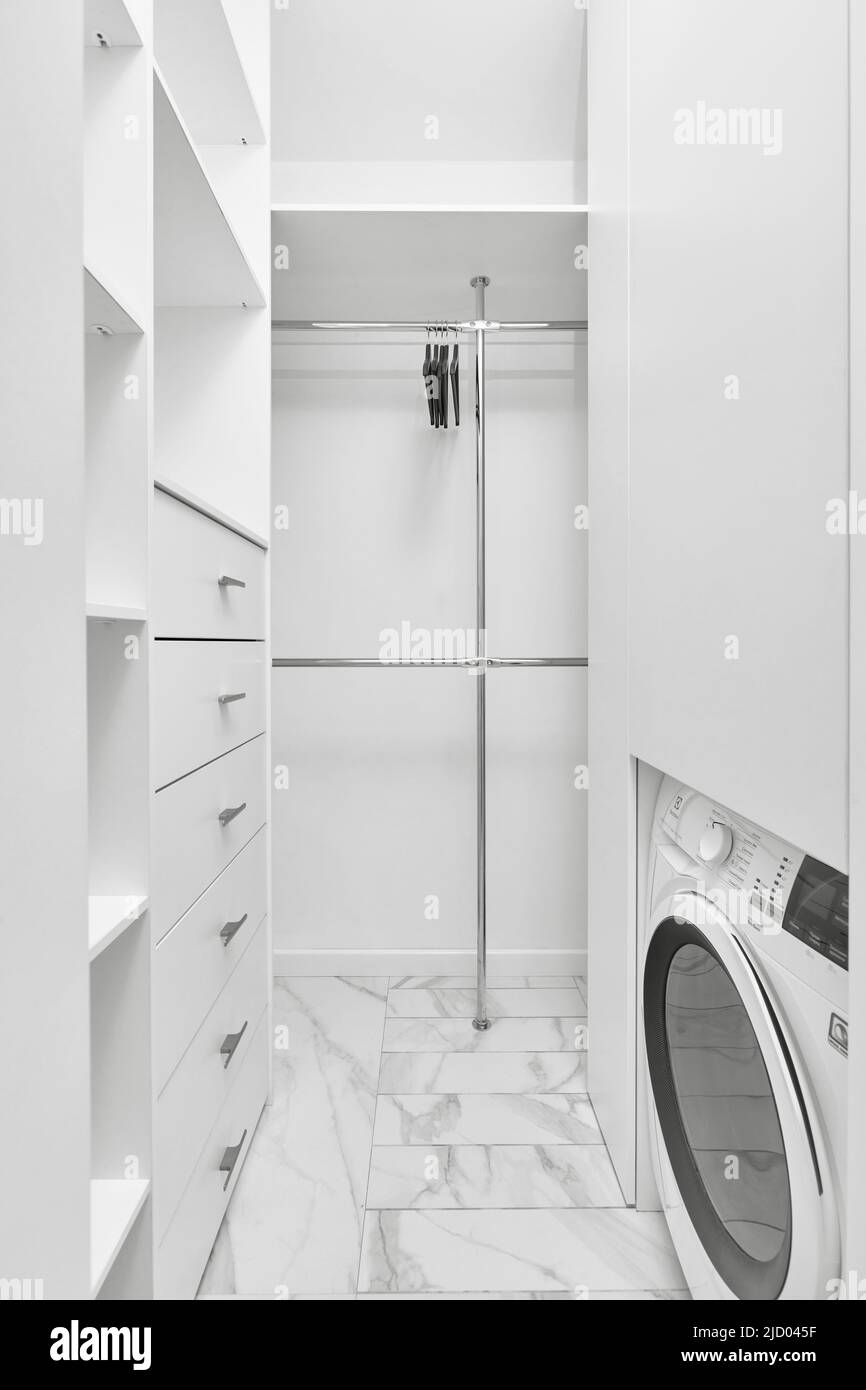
{"left": 664, "top": 941, "right": 791, "bottom": 1273}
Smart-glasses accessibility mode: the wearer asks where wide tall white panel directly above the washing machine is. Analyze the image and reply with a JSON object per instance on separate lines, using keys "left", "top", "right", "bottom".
{"left": 630, "top": 0, "right": 848, "bottom": 869}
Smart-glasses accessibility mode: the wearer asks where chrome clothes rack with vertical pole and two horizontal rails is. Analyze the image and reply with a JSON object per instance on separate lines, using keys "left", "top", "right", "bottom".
{"left": 271, "top": 275, "right": 588, "bottom": 1031}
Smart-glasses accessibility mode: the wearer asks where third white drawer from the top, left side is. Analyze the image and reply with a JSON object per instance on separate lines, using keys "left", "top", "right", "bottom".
{"left": 150, "top": 737, "right": 267, "bottom": 941}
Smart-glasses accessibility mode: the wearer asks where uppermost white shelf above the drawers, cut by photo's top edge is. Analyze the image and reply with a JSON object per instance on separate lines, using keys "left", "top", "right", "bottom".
{"left": 154, "top": 0, "right": 264, "bottom": 145}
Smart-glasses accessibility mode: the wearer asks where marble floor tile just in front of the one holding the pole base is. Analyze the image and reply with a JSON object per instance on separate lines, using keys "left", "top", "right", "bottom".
{"left": 379, "top": 1052, "right": 587, "bottom": 1095}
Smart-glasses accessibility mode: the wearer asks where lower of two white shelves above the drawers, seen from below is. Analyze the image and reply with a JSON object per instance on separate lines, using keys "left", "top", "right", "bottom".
{"left": 153, "top": 68, "right": 265, "bottom": 309}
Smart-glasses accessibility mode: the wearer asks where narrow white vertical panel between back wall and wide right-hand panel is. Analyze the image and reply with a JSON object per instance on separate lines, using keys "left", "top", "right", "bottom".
{"left": 588, "top": 0, "right": 635, "bottom": 1201}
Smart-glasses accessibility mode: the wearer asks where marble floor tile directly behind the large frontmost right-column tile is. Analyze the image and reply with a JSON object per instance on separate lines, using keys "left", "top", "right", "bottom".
{"left": 367, "top": 1144, "right": 624, "bottom": 1211}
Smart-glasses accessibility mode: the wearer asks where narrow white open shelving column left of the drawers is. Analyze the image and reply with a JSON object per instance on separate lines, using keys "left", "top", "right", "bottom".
{"left": 83, "top": 0, "right": 153, "bottom": 1298}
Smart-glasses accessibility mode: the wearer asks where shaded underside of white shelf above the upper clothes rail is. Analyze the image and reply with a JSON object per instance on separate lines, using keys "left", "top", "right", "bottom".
{"left": 271, "top": 209, "right": 587, "bottom": 321}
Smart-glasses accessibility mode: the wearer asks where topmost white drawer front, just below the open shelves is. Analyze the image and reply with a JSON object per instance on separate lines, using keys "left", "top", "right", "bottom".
{"left": 150, "top": 489, "right": 267, "bottom": 638}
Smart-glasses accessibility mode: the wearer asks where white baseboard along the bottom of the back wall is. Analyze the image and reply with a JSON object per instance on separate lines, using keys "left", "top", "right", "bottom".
{"left": 274, "top": 945, "right": 587, "bottom": 984}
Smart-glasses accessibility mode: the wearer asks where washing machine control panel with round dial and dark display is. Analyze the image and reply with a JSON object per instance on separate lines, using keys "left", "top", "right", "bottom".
{"left": 659, "top": 787, "right": 848, "bottom": 995}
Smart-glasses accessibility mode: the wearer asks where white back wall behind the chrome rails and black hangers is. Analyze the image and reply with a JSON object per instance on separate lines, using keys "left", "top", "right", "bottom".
{"left": 272, "top": 338, "right": 587, "bottom": 973}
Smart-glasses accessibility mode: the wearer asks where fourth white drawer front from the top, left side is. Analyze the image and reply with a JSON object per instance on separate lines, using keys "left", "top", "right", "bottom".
{"left": 153, "top": 828, "right": 267, "bottom": 1094}
